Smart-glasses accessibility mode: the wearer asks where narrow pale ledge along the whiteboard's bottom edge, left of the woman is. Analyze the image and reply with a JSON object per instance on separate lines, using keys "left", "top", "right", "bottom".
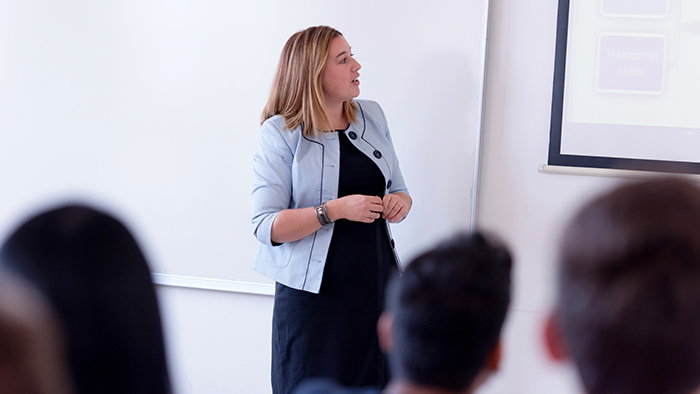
{"left": 151, "top": 273, "right": 275, "bottom": 296}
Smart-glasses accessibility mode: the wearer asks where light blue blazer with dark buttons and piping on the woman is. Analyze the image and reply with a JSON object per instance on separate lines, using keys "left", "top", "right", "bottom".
{"left": 252, "top": 100, "right": 408, "bottom": 293}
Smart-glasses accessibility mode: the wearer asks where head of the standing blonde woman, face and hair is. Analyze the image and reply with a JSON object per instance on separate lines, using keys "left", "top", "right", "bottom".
{"left": 261, "top": 26, "right": 360, "bottom": 135}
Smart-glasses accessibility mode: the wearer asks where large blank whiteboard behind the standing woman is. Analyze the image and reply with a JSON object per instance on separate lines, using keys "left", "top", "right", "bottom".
{"left": 0, "top": 0, "right": 484, "bottom": 290}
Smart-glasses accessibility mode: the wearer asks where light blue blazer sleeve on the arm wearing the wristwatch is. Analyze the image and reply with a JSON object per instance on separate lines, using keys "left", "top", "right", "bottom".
{"left": 251, "top": 119, "right": 294, "bottom": 246}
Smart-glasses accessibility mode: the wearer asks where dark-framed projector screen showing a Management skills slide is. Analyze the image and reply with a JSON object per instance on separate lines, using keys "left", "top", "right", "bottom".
{"left": 548, "top": 0, "right": 700, "bottom": 173}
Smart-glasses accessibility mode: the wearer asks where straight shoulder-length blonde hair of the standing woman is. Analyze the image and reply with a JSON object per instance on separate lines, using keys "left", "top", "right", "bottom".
{"left": 260, "top": 26, "right": 357, "bottom": 136}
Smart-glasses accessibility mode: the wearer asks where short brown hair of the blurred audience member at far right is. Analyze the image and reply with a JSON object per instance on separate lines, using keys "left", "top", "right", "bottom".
{"left": 555, "top": 179, "right": 700, "bottom": 394}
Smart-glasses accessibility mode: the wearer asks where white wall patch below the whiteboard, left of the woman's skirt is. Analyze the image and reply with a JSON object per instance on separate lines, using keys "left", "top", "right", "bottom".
{"left": 158, "top": 286, "right": 273, "bottom": 394}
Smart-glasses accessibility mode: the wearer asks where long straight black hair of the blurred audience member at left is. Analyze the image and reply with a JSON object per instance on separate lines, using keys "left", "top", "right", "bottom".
{"left": 0, "top": 206, "right": 170, "bottom": 394}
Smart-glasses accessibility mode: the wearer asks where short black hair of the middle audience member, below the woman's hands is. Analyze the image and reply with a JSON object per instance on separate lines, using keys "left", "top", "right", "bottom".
{"left": 387, "top": 234, "right": 511, "bottom": 391}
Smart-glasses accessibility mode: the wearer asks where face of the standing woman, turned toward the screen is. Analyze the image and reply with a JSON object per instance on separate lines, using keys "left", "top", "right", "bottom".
{"left": 322, "top": 36, "right": 362, "bottom": 108}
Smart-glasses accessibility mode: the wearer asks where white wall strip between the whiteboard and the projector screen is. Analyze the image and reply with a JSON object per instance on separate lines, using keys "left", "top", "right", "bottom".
{"left": 479, "top": 0, "right": 619, "bottom": 394}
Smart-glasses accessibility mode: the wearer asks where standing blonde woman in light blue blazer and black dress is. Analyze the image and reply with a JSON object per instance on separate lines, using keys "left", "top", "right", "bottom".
{"left": 252, "top": 26, "right": 411, "bottom": 394}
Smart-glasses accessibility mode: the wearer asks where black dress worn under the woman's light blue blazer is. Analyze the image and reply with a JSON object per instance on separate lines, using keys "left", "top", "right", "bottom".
{"left": 272, "top": 131, "right": 396, "bottom": 394}
